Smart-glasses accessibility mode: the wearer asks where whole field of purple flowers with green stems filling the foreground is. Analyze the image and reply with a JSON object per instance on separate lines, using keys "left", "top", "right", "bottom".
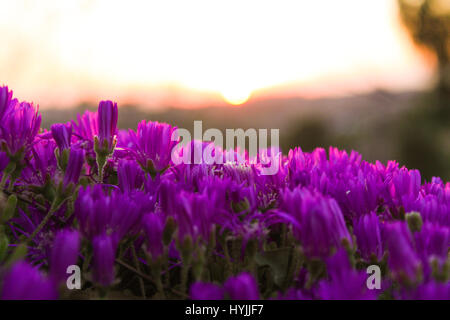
{"left": 0, "top": 86, "right": 450, "bottom": 300}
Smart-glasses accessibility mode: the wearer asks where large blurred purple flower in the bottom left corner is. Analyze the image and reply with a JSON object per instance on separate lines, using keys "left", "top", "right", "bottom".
{"left": 1, "top": 261, "right": 58, "bottom": 300}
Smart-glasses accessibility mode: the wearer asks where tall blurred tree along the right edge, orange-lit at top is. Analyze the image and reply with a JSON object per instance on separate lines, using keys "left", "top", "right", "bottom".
{"left": 398, "top": 0, "right": 450, "bottom": 180}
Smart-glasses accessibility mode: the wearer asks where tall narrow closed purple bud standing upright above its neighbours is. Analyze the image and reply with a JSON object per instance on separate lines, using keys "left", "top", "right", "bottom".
{"left": 97, "top": 100, "right": 118, "bottom": 151}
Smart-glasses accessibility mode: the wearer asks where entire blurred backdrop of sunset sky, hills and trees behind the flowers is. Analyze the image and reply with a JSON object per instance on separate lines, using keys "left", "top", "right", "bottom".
{"left": 0, "top": 0, "right": 450, "bottom": 181}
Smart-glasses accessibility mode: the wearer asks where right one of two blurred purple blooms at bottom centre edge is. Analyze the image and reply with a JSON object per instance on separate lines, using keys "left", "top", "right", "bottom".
{"left": 224, "top": 272, "right": 259, "bottom": 300}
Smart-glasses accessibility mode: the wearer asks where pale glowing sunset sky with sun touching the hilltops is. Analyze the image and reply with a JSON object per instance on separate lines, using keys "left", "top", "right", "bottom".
{"left": 0, "top": 0, "right": 432, "bottom": 108}
